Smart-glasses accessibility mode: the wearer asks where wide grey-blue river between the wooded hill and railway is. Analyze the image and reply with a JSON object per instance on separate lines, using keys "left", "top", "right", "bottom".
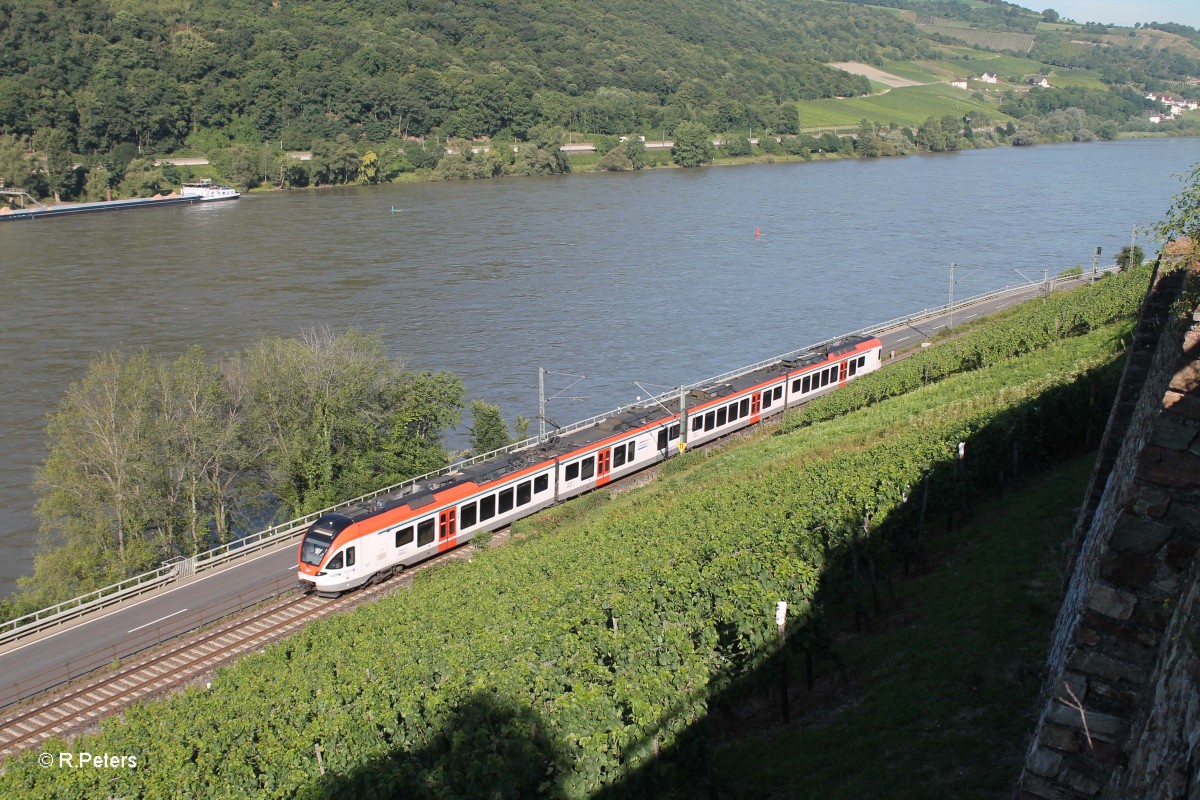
{"left": 0, "top": 139, "right": 1200, "bottom": 596}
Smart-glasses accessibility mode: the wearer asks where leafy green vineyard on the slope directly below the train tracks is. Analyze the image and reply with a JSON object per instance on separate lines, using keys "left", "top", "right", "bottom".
{"left": 0, "top": 272, "right": 1145, "bottom": 800}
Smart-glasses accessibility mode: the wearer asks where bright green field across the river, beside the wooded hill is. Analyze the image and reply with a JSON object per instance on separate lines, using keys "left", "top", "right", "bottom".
{"left": 797, "top": 84, "right": 1009, "bottom": 130}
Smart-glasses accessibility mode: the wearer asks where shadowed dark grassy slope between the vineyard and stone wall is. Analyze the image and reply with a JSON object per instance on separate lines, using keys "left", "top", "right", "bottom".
{"left": 716, "top": 457, "right": 1092, "bottom": 800}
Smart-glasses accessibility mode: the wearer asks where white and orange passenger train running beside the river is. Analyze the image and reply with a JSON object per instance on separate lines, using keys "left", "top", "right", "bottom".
{"left": 298, "top": 337, "right": 883, "bottom": 597}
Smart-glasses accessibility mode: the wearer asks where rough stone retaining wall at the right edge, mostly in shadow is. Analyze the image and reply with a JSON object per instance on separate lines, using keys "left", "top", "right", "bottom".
{"left": 1016, "top": 257, "right": 1200, "bottom": 800}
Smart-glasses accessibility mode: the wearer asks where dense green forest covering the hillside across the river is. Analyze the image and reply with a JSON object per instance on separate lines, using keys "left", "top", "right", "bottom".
{"left": 0, "top": 0, "right": 923, "bottom": 156}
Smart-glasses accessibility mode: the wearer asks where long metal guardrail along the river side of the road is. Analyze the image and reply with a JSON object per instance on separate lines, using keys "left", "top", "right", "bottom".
{"left": 0, "top": 266, "right": 1117, "bottom": 646}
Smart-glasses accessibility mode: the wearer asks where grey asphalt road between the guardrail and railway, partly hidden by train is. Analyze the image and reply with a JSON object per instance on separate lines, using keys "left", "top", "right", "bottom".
{"left": 0, "top": 272, "right": 1099, "bottom": 706}
